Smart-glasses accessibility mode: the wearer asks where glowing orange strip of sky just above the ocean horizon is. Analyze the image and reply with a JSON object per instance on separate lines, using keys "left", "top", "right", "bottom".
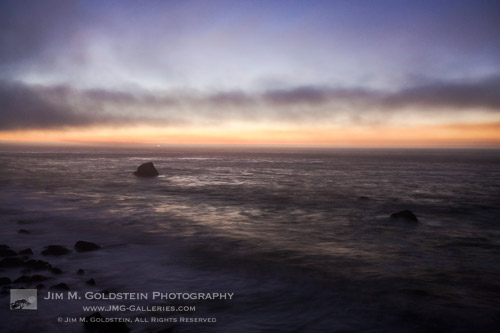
{"left": 0, "top": 122, "right": 500, "bottom": 147}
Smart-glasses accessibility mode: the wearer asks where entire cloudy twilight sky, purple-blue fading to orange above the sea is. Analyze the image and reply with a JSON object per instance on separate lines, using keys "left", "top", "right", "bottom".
{"left": 0, "top": 0, "right": 500, "bottom": 147}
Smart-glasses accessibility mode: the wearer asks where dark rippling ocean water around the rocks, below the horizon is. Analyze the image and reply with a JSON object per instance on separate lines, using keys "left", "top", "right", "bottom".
{"left": 0, "top": 146, "right": 500, "bottom": 333}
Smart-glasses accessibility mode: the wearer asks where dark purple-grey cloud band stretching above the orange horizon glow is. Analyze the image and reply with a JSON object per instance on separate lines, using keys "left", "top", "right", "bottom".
{"left": 0, "top": 75, "right": 500, "bottom": 131}
